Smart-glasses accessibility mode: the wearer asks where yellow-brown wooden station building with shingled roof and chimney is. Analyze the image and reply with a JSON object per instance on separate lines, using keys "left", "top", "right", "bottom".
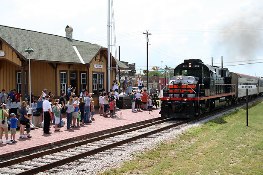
{"left": 0, "top": 25, "right": 127, "bottom": 104}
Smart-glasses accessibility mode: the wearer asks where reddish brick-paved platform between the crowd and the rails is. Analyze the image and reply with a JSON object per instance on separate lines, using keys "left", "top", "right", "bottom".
{"left": 0, "top": 109, "right": 160, "bottom": 156}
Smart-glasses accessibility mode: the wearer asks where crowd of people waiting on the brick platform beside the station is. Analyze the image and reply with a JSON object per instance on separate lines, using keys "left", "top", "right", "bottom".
{"left": 0, "top": 78, "right": 160, "bottom": 144}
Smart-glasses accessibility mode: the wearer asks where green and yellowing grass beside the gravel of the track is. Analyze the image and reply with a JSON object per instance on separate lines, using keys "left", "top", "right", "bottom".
{"left": 103, "top": 103, "right": 263, "bottom": 175}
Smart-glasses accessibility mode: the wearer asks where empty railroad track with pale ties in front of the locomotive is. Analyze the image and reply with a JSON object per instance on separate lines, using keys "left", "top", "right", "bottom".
{"left": 0, "top": 118, "right": 187, "bottom": 174}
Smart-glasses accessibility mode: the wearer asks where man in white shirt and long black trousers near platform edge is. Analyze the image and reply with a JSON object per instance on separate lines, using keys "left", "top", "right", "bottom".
{"left": 43, "top": 95, "right": 52, "bottom": 134}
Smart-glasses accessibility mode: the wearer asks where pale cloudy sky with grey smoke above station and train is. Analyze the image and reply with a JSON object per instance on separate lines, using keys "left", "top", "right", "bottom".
{"left": 0, "top": 0, "right": 263, "bottom": 76}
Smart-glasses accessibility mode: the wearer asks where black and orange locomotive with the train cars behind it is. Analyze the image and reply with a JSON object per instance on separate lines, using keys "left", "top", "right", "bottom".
{"left": 160, "top": 59, "right": 263, "bottom": 118}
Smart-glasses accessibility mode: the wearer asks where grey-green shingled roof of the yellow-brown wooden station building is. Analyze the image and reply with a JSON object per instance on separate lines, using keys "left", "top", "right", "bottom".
{"left": 0, "top": 25, "right": 127, "bottom": 68}
